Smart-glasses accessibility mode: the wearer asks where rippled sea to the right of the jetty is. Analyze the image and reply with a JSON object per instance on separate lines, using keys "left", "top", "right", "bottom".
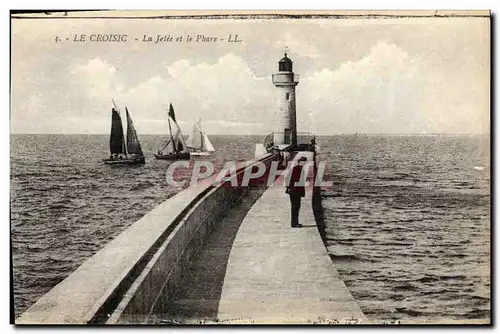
{"left": 320, "top": 136, "right": 490, "bottom": 320}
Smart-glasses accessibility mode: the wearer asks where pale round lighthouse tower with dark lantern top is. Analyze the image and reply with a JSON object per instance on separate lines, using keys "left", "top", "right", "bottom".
{"left": 273, "top": 53, "right": 299, "bottom": 146}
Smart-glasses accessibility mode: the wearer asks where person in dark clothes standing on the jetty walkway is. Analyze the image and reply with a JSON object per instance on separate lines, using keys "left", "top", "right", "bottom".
{"left": 285, "top": 157, "right": 307, "bottom": 227}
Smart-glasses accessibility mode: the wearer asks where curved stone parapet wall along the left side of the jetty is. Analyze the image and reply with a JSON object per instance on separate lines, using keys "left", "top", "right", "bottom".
{"left": 15, "top": 154, "right": 277, "bottom": 324}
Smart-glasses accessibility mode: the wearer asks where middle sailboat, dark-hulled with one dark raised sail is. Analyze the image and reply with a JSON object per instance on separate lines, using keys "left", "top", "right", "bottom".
{"left": 155, "top": 103, "right": 190, "bottom": 160}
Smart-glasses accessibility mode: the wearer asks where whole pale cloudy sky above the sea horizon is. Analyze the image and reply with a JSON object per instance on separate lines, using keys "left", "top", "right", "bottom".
{"left": 11, "top": 17, "right": 490, "bottom": 135}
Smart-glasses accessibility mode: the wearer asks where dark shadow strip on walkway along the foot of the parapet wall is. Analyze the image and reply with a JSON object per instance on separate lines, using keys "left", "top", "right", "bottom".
{"left": 149, "top": 186, "right": 266, "bottom": 324}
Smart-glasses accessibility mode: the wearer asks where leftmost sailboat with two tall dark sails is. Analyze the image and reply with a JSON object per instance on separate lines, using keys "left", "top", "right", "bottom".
{"left": 103, "top": 101, "right": 146, "bottom": 165}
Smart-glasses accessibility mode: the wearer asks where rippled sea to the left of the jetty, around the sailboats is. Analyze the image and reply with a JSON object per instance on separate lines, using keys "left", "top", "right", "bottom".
{"left": 11, "top": 135, "right": 263, "bottom": 316}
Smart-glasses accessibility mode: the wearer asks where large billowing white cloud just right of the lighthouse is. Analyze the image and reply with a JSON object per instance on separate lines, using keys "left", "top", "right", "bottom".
{"left": 302, "top": 41, "right": 431, "bottom": 133}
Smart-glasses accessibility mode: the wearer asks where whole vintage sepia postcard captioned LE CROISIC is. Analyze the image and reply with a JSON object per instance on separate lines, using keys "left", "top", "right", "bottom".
{"left": 10, "top": 10, "right": 491, "bottom": 325}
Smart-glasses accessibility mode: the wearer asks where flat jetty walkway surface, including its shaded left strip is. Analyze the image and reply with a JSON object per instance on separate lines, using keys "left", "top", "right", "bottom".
{"left": 154, "top": 151, "right": 367, "bottom": 324}
